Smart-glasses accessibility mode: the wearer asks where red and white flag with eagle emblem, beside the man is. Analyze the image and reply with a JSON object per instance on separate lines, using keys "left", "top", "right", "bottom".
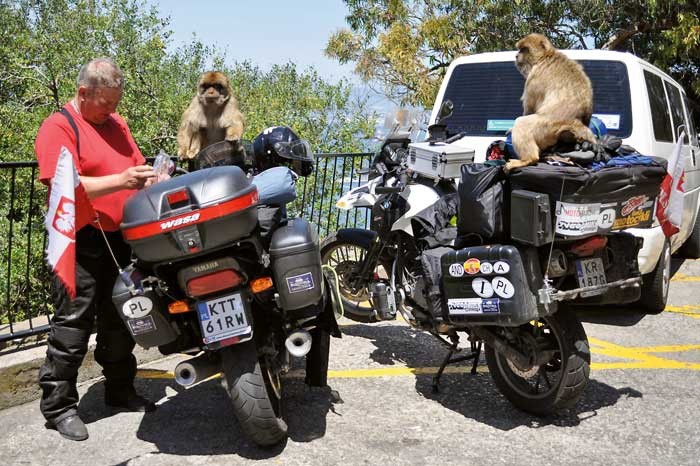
{"left": 45, "top": 147, "right": 97, "bottom": 299}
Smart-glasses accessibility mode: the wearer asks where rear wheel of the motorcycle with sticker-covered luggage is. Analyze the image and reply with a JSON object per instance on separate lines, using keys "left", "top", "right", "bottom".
{"left": 486, "top": 310, "right": 591, "bottom": 416}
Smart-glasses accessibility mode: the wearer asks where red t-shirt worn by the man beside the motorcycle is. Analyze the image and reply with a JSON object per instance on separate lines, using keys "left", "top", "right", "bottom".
{"left": 34, "top": 104, "right": 146, "bottom": 231}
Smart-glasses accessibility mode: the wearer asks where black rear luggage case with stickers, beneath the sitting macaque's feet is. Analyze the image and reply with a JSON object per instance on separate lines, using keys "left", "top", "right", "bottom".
{"left": 509, "top": 161, "right": 666, "bottom": 238}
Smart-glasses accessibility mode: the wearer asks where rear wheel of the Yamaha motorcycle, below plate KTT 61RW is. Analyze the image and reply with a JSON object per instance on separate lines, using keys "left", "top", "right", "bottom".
{"left": 221, "top": 341, "right": 287, "bottom": 446}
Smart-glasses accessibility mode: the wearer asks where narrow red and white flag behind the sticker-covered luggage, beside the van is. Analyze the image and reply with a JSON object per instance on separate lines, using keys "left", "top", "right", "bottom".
{"left": 656, "top": 131, "right": 685, "bottom": 238}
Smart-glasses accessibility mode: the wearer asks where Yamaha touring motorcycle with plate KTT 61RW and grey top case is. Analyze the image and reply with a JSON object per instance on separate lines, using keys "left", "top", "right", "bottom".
{"left": 113, "top": 127, "right": 340, "bottom": 446}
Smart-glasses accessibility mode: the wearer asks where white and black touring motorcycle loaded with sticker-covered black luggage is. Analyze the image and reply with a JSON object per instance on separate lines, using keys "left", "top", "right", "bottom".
{"left": 321, "top": 109, "right": 665, "bottom": 415}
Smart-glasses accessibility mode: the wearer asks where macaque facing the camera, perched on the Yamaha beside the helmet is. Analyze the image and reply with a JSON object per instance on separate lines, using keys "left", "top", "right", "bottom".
{"left": 177, "top": 71, "right": 244, "bottom": 159}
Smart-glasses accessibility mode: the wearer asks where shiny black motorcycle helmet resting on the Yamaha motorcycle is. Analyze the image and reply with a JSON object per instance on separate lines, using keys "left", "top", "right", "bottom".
{"left": 253, "top": 126, "right": 314, "bottom": 176}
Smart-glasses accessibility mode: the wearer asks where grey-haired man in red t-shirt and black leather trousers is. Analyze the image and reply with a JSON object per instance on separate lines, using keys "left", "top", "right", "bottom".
{"left": 34, "top": 58, "right": 155, "bottom": 440}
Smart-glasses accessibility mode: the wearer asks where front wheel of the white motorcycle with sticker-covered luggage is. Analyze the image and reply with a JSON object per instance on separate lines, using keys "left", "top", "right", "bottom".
{"left": 321, "top": 235, "right": 390, "bottom": 323}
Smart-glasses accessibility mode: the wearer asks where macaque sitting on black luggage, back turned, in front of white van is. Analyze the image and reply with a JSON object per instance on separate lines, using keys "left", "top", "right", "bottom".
{"left": 505, "top": 34, "right": 595, "bottom": 171}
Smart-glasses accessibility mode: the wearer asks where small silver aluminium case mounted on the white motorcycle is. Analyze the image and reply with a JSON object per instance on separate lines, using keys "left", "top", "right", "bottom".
{"left": 408, "top": 142, "right": 474, "bottom": 179}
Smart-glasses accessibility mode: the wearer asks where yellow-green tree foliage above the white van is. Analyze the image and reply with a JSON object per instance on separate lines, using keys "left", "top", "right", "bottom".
{"left": 326, "top": 0, "right": 700, "bottom": 107}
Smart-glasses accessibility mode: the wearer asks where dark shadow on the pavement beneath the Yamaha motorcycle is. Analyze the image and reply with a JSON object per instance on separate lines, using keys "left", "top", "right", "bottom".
{"left": 78, "top": 364, "right": 340, "bottom": 459}
